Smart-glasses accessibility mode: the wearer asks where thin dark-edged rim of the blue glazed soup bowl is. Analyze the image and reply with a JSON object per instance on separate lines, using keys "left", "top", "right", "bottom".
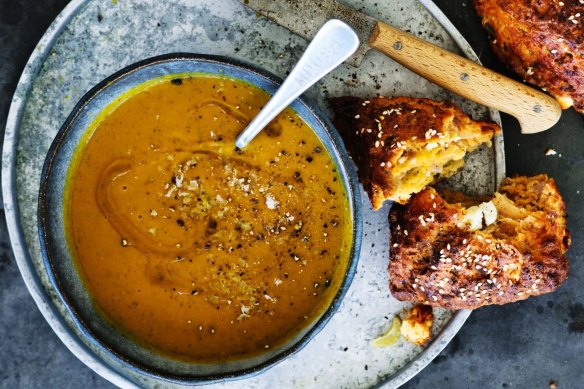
{"left": 38, "top": 53, "right": 363, "bottom": 385}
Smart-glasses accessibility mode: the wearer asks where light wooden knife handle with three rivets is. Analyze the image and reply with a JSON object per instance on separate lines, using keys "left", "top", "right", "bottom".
{"left": 369, "top": 22, "right": 562, "bottom": 134}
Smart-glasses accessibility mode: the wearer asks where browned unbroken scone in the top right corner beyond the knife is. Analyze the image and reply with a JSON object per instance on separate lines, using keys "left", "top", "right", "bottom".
{"left": 474, "top": 0, "right": 584, "bottom": 113}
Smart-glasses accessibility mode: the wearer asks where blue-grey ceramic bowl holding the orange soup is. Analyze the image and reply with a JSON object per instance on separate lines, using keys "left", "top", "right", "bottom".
{"left": 38, "top": 54, "right": 362, "bottom": 385}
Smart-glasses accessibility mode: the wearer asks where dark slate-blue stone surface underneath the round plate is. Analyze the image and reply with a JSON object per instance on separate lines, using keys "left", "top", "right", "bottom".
{"left": 0, "top": 0, "right": 584, "bottom": 388}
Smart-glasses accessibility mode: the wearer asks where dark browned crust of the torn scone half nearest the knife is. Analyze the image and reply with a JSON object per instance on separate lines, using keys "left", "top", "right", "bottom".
{"left": 331, "top": 97, "right": 500, "bottom": 209}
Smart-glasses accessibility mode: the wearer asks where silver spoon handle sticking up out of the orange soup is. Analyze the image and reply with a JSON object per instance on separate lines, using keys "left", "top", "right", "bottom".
{"left": 235, "top": 19, "right": 359, "bottom": 148}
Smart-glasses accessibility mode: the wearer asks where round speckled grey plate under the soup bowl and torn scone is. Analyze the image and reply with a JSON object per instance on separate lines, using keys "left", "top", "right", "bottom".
{"left": 2, "top": 0, "right": 504, "bottom": 388}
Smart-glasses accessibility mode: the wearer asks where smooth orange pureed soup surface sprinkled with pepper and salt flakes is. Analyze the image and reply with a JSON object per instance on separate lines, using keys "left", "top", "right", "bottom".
{"left": 65, "top": 74, "right": 352, "bottom": 361}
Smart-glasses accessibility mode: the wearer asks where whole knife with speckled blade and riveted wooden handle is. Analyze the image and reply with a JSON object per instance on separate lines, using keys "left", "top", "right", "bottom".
{"left": 240, "top": 0, "right": 562, "bottom": 134}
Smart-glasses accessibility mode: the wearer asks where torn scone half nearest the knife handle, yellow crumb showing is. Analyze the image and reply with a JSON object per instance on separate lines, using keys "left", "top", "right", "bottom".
{"left": 331, "top": 97, "right": 500, "bottom": 209}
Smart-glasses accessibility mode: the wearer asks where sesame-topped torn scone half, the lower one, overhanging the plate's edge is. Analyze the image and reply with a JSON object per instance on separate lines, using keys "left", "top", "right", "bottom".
{"left": 389, "top": 175, "right": 570, "bottom": 309}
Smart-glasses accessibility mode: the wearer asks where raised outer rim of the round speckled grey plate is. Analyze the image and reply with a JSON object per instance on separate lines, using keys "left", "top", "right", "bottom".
{"left": 1, "top": 0, "right": 505, "bottom": 388}
